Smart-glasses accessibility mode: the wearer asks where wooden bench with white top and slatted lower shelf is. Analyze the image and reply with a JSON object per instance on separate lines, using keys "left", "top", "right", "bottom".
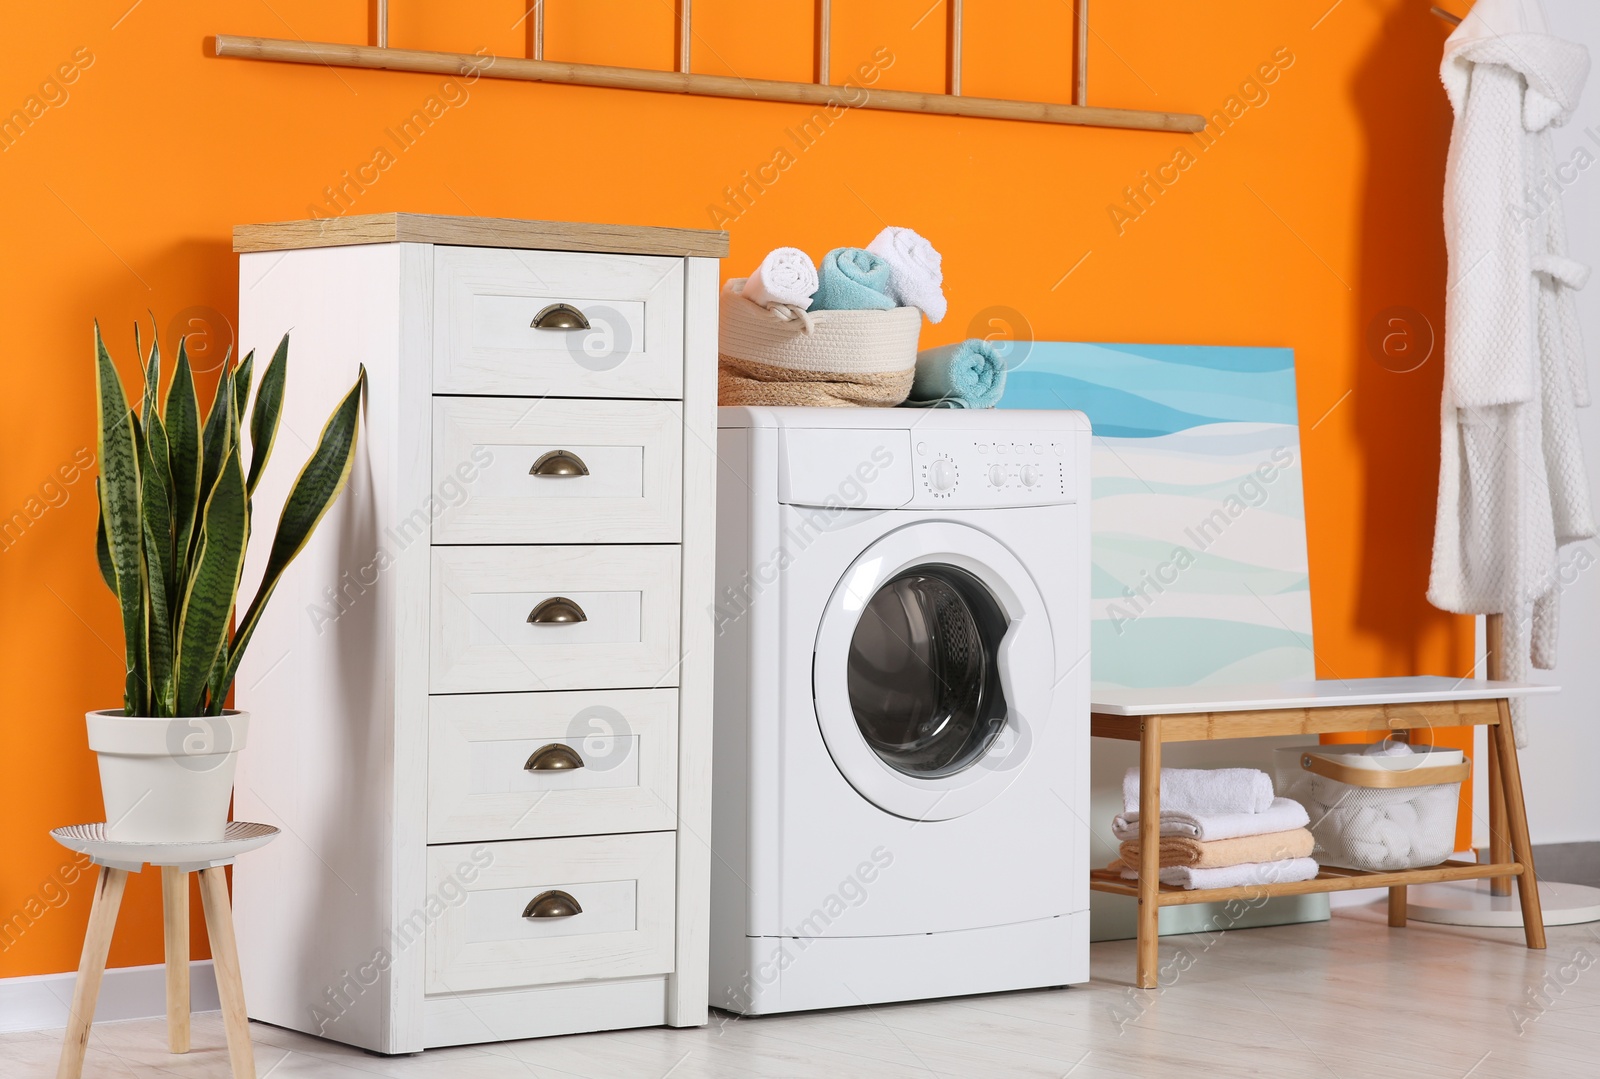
{"left": 1090, "top": 677, "right": 1557, "bottom": 989}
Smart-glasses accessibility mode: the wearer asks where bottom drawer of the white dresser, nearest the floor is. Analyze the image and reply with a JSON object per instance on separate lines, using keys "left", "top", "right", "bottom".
{"left": 424, "top": 832, "right": 677, "bottom": 993}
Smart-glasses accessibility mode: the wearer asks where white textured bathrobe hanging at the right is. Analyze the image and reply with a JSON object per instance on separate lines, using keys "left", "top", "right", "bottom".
{"left": 1427, "top": 0, "right": 1595, "bottom": 746}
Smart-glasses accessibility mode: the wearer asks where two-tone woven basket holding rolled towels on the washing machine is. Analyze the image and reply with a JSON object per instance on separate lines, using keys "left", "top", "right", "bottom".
{"left": 717, "top": 282, "right": 922, "bottom": 407}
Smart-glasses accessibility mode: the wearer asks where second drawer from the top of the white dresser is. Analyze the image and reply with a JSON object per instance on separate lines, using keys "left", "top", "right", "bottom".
{"left": 434, "top": 397, "right": 683, "bottom": 543}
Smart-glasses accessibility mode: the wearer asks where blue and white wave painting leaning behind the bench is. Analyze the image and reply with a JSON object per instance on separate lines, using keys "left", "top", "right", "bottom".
{"left": 1000, "top": 341, "right": 1315, "bottom": 687}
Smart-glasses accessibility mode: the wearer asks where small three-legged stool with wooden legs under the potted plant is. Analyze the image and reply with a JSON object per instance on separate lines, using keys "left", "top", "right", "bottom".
{"left": 50, "top": 821, "right": 278, "bottom": 1079}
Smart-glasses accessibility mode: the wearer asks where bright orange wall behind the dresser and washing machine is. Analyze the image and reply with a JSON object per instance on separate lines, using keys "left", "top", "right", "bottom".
{"left": 0, "top": 0, "right": 1472, "bottom": 977}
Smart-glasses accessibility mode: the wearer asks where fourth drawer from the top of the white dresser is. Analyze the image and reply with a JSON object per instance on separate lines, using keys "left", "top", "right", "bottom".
{"left": 427, "top": 690, "right": 678, "bottom": 844}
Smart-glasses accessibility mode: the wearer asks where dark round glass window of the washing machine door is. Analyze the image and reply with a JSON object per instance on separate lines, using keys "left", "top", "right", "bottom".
{"left": 845, "top": 565, "right": 1008, "bottom": 778}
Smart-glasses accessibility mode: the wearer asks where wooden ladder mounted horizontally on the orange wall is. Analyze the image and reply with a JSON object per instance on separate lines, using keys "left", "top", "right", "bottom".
{"left": 208, "top": 0, "right": 1205, "bottom": 131}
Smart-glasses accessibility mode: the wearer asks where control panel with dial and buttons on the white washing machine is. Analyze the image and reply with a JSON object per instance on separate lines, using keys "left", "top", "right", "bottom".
{"left": 910, "top": 431, "right": 1077, "bottom": 506}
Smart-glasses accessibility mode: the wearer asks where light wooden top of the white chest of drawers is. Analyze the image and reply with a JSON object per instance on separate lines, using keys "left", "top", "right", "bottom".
{"left": 234, "top": 213, "right": 728, "bottom": 258}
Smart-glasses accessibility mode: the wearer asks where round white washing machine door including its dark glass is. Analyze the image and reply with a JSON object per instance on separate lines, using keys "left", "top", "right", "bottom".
{"left": 811, "top": 522, "right": 1058, "bottom": 820}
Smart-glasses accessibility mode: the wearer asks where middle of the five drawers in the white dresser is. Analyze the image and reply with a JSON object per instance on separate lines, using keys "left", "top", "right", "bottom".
{"left": 429, "top": 546, "right": 678, "bottom": 693}
